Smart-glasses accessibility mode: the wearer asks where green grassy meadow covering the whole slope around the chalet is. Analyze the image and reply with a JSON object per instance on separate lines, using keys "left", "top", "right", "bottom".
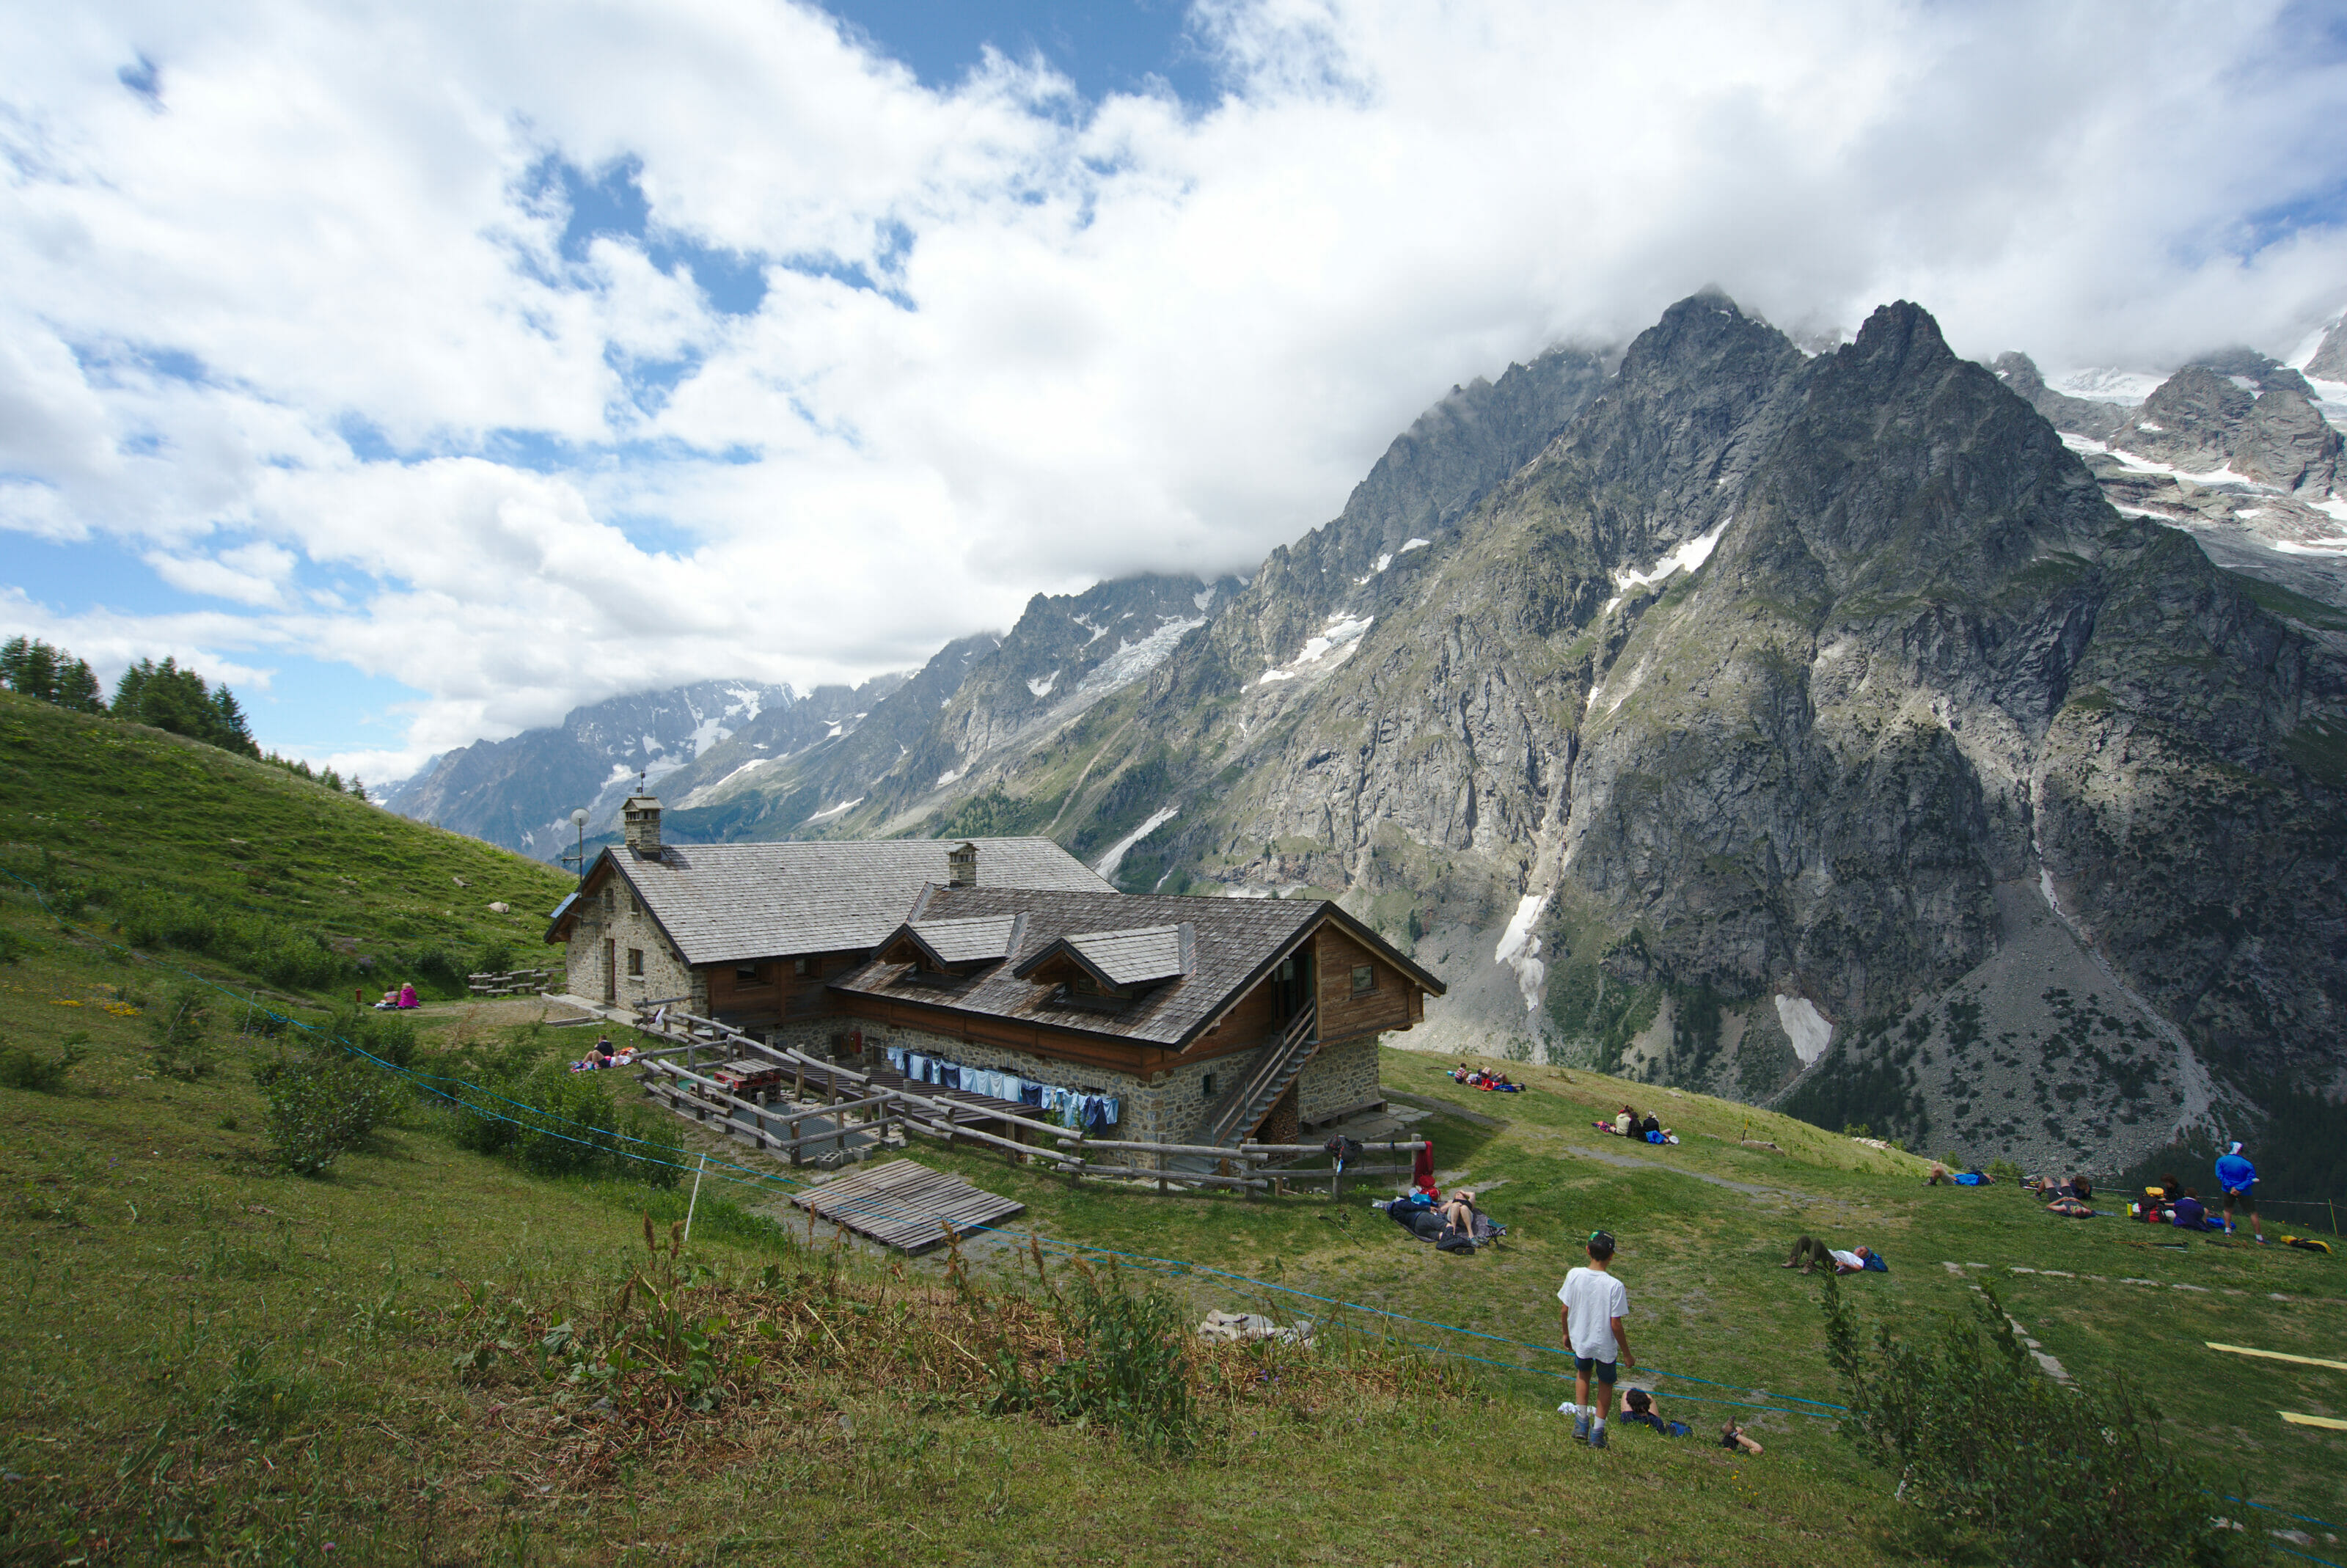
{"left": 0, "top": 700, "right": 2347, "bottom": 1566}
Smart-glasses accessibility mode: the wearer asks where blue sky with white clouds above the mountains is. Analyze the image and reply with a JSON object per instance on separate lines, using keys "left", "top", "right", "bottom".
{"left": 0, "top": 0, "right": 2347, "bottom": 780}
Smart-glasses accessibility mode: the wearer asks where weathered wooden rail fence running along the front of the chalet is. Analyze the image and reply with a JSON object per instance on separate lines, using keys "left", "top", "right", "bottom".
{"left": 636, "top": 1007, "right": 1424, "bottom": 1197}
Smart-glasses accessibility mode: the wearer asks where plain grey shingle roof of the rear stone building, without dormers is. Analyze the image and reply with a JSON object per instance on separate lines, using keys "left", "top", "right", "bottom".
{"left": 547, "top": 838, "right": 1117, "bottom": 964}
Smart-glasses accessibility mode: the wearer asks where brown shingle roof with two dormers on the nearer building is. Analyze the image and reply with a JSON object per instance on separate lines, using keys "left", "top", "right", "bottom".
{"left": 831, "top": 885, "right": 1443, "bottom": 1049}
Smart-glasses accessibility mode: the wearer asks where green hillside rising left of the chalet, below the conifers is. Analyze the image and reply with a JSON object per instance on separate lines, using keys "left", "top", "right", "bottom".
{"left": 0, "top": 692, "right": 573, "bottom": 995}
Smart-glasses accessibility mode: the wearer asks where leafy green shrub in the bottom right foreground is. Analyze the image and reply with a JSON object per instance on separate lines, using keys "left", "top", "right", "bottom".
{"left": 1826, "top": 1277, "right": 2241, "bottom": 1568}
